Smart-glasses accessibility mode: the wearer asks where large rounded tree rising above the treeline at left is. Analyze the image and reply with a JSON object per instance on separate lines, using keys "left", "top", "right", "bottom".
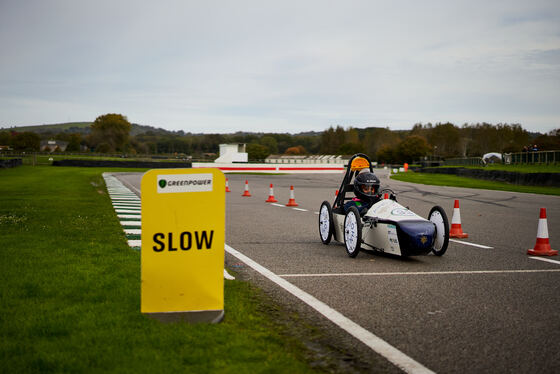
{"left": 90, "top": 113, "right": 132, "bottom": 152}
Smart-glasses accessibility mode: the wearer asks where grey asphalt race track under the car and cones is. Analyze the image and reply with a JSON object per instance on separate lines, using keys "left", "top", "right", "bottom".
{"left": 115, "top": 170, "right": 560, "bottom": 373}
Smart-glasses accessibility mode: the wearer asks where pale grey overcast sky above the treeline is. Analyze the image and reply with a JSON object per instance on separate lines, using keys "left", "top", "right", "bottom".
{"left": 0, "top": 0, "right": 560, "bottom": 133}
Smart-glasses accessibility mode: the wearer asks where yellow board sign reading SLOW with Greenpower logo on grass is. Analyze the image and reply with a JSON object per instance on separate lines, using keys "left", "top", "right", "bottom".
{"left": 141, "top": 169, "right": 225, "bottom": 313}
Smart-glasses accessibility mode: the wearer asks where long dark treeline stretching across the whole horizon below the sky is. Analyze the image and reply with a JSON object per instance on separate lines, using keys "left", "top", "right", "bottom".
{"left": 0, "top": 114, "right": 560, "bottom": 162}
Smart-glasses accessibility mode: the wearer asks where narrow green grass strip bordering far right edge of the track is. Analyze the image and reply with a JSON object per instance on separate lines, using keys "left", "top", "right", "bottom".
{"left": 391, "top": 171, "right": 560, "bottom": 195}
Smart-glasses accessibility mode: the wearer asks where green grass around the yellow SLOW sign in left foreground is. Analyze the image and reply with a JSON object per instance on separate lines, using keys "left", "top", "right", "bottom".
{"left": 0, "top": 166, "right": 331, "bottom": 373}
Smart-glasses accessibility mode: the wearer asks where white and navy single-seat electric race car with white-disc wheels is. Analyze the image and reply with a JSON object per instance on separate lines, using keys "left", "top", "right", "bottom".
{"left": 319, "top": 153, "right": 449, "bottom": 257}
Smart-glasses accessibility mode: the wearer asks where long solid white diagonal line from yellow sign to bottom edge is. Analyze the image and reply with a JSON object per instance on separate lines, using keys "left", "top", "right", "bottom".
{"left": 225, "top": 244, "right": 433, "bottom": 373}
